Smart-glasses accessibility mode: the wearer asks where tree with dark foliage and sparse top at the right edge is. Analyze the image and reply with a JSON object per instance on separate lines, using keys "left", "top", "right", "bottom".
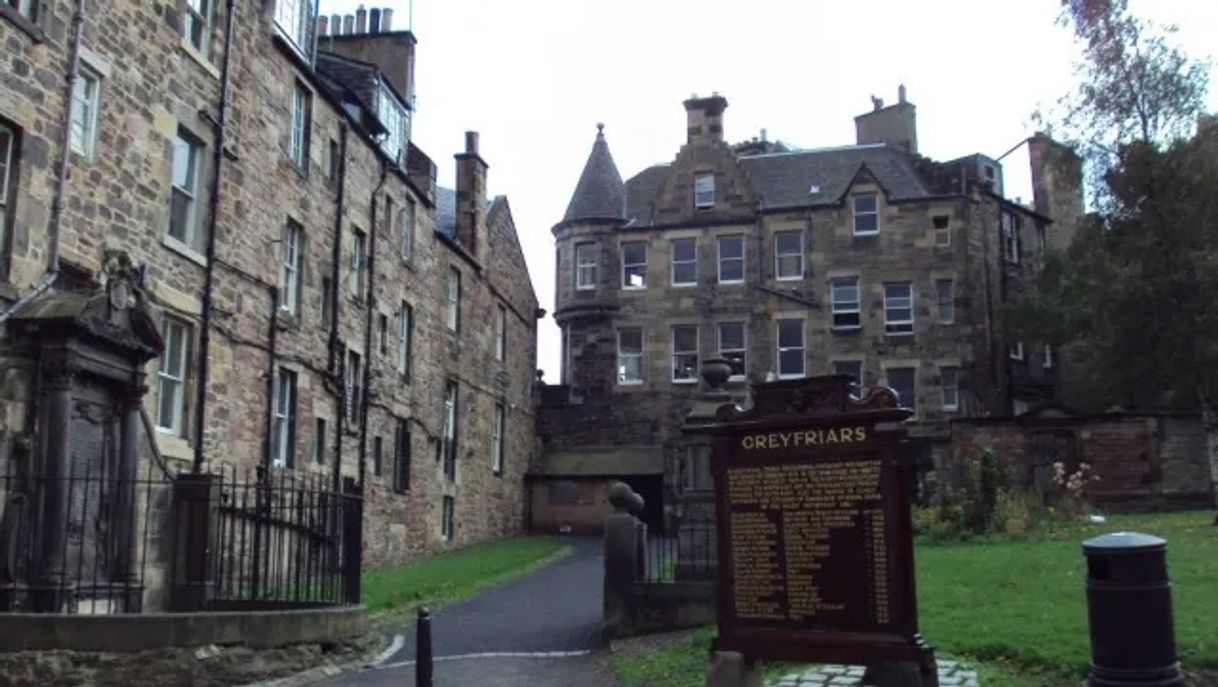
{"left": 1007, "top": 0, "right": 1218, "bottom": 503}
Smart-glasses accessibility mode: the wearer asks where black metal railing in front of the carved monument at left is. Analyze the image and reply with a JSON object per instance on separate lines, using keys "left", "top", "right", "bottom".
{"left": 0, "top": 460, "right": 363, "bottom": 614}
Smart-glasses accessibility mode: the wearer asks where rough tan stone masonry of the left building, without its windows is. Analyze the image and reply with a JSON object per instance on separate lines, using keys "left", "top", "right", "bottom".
{"left": 0, "top": 0, "right": 537, "bottom": 565}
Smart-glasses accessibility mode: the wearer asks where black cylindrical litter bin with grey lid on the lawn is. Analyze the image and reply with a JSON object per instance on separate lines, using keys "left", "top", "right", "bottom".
{"left": 1083, "top": 532, "right": 1184, "bottom": 687}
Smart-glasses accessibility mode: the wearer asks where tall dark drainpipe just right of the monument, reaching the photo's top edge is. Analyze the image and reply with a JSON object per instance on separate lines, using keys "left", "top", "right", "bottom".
{"left": 192, "top": 0, "right": 236, "bottom": 474}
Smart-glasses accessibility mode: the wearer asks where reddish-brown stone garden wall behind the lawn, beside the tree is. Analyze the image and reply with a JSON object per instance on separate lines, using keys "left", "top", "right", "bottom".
{"left": 934, "top": 413, "right": 1213, "bottom": 512}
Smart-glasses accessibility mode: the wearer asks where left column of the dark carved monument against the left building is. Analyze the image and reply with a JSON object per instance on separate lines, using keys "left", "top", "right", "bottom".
{"left": 29, "top": 364, "right": 76, "bottom": 613}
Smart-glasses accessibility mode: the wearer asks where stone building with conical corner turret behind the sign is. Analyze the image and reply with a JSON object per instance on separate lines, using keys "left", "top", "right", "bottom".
{"left": 533, "top": 86, "right": 1082, "bottom": 528}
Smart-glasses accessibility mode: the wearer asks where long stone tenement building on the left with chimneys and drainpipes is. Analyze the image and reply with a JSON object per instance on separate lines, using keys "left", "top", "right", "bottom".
{"left": 0, "top": 0, "right": 540, "bottom": 565}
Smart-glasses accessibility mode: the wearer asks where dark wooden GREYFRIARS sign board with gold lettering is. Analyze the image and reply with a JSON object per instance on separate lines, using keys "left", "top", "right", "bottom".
{"left": 702, "top": 376, "right": 934, "bottom": 675}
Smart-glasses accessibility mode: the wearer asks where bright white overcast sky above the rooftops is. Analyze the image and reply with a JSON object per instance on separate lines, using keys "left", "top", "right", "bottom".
{"left": 320, "top": 0, "right": 1218, "bottom": 384}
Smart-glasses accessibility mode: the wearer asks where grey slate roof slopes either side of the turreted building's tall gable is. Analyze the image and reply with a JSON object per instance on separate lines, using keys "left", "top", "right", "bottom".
{"left": 626, "top": 144, "right": 933, "bottom": 225}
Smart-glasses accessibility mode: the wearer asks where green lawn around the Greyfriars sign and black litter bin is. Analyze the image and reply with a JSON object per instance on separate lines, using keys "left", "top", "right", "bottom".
{"left": 614, "top": 512, "right": 1218, "bottom": 687}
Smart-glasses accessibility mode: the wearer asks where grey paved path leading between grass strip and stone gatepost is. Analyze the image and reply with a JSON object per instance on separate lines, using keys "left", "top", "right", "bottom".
{"left": 329, "top": 538, "right": 614, "bottom": 687}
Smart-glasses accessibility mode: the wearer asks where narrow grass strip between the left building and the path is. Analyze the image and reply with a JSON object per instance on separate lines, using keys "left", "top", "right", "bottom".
{"left": 361, "top": 537, "right": 570, "bottom": 613}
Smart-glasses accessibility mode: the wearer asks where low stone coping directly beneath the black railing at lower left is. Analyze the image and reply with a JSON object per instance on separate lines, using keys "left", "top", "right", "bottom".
{"left": 0, "top": 605, "right": 368, "bottom": 653}
